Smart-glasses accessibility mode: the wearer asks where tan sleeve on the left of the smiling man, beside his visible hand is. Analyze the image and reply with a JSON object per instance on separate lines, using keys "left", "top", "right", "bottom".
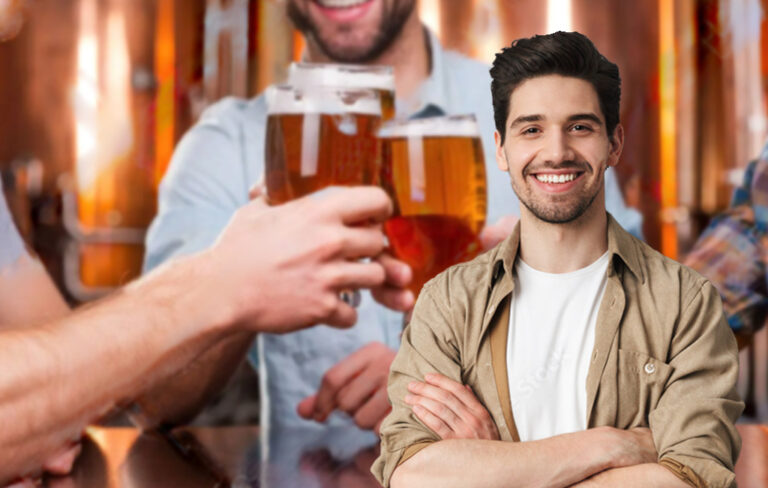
{"left": 371, "top": 277, "right": 461, "bottom": 486}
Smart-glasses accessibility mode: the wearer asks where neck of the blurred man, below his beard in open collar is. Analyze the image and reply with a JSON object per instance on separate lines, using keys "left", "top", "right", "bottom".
{"left": 307, "top": 8, "right": 430, "bottom": 99}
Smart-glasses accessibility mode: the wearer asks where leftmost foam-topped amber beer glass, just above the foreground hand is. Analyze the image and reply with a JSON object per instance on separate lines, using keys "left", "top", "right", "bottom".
{"left": 265, "top": 85, "right": 381, "bottom": 204}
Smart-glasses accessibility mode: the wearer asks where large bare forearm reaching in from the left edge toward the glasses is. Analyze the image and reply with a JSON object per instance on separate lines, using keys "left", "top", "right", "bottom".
{"left": 0, "top": 257, "right": 225, "bottom": 484}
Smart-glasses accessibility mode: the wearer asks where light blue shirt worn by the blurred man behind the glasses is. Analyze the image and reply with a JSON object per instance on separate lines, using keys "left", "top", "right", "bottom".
{"left": 145, "top": 30, "right": 642, "bottom": 435}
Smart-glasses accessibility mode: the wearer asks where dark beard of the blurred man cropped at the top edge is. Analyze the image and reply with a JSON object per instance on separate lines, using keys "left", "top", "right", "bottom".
{"left": 288, "top": 1, "right": 416, "bottom": 64}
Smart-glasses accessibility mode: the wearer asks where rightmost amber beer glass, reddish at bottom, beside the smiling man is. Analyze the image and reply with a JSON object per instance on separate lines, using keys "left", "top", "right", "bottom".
{"left": 380, "top": 116, "right": 487, "bottom": 295}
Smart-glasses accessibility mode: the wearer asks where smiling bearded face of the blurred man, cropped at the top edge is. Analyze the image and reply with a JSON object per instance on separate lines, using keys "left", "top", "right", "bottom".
{"left": 288, "top": 0, "right": 416, "bottom": 63}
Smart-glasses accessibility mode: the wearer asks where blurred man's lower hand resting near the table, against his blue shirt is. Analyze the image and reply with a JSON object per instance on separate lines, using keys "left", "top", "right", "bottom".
{"left": 297, "top": 342, "right": 395, "bottom": 434}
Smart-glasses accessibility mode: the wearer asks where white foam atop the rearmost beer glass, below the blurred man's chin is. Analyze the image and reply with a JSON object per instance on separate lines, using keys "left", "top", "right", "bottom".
{"left": 288, "top": 63, "right": 395, "bottom": 91}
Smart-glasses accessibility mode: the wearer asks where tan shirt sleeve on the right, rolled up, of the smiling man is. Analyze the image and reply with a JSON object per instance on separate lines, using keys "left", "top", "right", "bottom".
{"left": 649, "top": 282, "right": 744, "bottom": 488}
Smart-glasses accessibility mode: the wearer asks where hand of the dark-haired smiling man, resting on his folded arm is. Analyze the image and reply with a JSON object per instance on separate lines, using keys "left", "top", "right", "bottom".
{"left": 405, "top": 373, "right": 500, "bottom": 440}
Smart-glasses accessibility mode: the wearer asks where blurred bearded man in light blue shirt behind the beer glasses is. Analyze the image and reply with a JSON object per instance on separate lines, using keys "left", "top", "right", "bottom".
{"left": 145, "top": 0, "right": 642, "bottom": 438}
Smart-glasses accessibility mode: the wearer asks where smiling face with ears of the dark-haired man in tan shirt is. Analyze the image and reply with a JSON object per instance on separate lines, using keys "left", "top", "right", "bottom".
{"left": 496, "top": 75, "right": 624, "bottom": 224}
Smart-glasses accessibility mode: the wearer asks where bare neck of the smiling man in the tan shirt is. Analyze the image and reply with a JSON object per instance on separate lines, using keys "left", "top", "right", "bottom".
{"left": 519, "top": 197, "right": 608, "bottom": 273}
